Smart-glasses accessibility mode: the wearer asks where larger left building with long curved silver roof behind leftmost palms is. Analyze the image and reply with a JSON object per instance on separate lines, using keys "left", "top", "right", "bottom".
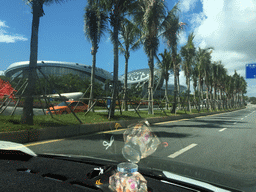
{"left": 4, "top": 61, "right": 113, "bottom": 82}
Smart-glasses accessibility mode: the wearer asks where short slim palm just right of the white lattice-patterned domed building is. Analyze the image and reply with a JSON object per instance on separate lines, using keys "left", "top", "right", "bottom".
{"left": 158, "top": 49, "right": 172, "bottom": 110}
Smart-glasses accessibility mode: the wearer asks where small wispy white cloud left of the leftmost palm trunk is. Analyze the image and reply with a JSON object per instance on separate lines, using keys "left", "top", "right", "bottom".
{"left": 0, "top": 21, "right": 28, "bottom": 43}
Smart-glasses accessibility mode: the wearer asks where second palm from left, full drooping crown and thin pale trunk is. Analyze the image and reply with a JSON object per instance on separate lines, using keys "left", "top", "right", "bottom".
{"left": 84, "top": 0, "right": 107, "bottom": 111}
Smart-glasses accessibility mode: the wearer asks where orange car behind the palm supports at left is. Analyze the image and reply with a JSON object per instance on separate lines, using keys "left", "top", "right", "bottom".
{"left": 46, "top": 101, "right": 88, "bottom": 114}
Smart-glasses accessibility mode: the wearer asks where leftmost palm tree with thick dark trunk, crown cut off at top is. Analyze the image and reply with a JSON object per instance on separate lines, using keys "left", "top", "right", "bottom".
{"left": 21, "top": 0, "right": 69, "bottom": 125}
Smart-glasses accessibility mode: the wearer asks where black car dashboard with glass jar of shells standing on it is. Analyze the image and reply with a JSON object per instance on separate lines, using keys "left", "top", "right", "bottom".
{"left": 0, "top": 150, "right": 248, "bottom": 192}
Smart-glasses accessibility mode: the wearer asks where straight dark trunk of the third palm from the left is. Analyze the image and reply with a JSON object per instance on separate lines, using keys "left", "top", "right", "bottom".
{"left": 108, "top": 22, "right": 120, "bottom": 119}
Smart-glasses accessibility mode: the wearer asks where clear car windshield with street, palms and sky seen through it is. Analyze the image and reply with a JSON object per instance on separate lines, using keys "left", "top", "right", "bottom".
{"left": 0, "top": 0, "right": 256, "bottom": 191}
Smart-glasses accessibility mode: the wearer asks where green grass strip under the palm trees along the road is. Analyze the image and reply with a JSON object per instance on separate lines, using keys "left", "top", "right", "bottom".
{"left": 0, "top": 106, "right": 242, "bottom": 132}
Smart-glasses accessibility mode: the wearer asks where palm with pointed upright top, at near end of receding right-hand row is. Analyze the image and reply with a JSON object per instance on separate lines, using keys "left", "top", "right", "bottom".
{"left": 181, "top": 33, "right": 195, "bottom": 112}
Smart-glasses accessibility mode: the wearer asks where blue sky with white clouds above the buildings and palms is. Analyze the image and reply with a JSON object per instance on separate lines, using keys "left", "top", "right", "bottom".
{"left": 0, "top": 0, "right": 256, "bottom": 97}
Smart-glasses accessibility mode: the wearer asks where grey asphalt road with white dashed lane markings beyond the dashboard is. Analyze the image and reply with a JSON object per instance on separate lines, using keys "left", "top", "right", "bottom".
{"left": 23, "top": 107, "right": 256, "bottom": 191}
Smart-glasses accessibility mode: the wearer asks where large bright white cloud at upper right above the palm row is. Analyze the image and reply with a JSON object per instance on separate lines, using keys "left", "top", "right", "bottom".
{"left": 190, "top": 0, "right": 256, "bottom": 96}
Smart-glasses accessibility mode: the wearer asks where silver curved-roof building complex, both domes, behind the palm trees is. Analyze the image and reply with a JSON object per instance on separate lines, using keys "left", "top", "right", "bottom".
{"left": 4, "top": 61, "right": 186, "bottom": 97}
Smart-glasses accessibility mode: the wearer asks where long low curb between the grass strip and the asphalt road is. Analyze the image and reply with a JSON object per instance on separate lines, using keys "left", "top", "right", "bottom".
{"left": 0, "top": 109, "right": 244, "bottom": 144}
